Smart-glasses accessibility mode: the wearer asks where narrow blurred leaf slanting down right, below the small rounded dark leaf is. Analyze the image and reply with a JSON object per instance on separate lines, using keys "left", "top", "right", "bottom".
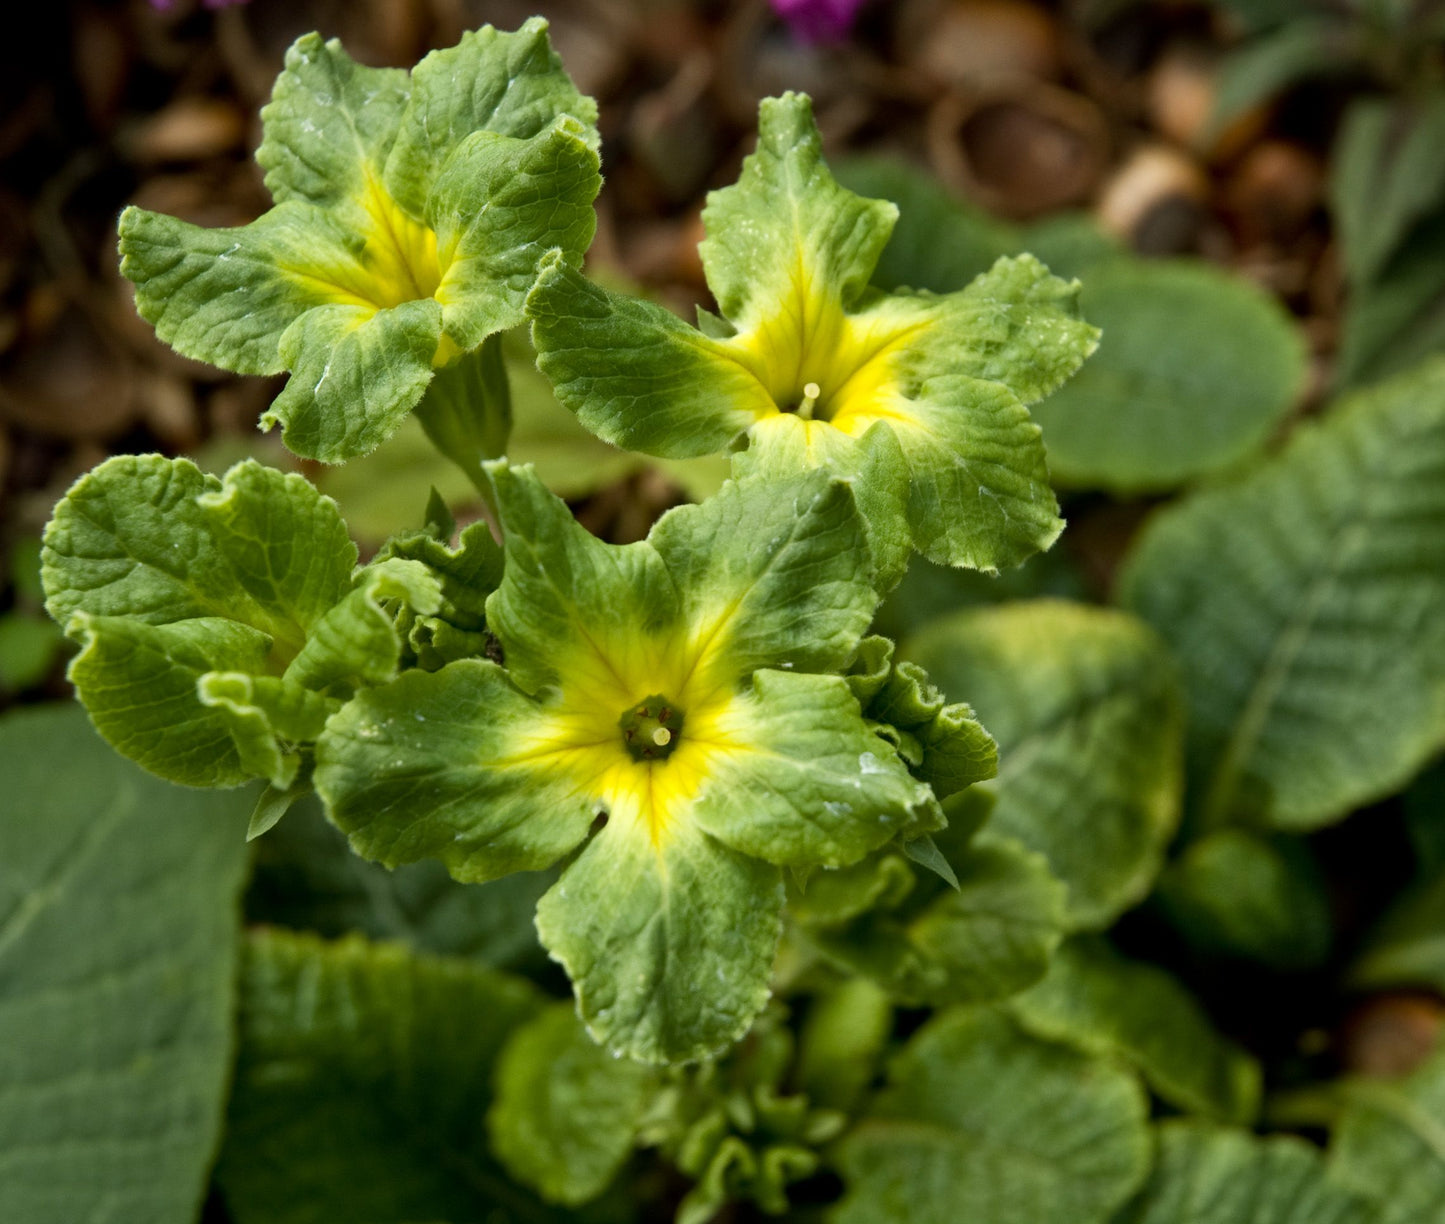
{"left": 1009, "top": 936, "right": 1260, "bottom": 1126}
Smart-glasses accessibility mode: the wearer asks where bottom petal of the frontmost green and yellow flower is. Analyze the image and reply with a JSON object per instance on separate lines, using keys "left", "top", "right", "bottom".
{"left": 538, "top": 824, "right": 783, "bottom": 1062}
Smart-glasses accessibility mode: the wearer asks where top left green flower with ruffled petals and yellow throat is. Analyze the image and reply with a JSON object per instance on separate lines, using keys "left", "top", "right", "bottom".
{"left": 120, "top": 19, "right": 601, "bottom": 462}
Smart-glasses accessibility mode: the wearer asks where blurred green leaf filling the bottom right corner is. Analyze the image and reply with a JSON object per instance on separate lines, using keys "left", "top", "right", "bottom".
{"left": 1329, "top": 1052, "right": 1445, "bottom": 1224}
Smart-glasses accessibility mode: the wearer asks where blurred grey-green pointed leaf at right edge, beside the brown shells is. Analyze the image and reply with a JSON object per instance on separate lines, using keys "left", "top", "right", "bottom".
{"left": 1329, "top": 94, "right": 1445, "bottom": 285}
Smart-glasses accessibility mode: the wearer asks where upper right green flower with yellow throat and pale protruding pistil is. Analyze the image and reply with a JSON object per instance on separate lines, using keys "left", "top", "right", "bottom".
{"left": 527, "top": 94, "right": 1098, "bottom": 587}
